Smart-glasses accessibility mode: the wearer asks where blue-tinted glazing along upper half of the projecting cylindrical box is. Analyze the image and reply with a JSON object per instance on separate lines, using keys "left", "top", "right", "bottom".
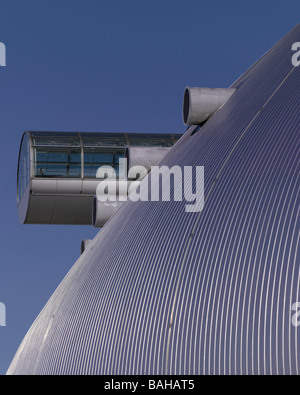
{"left": 29, "top": 132, "right": 181, "bottom": 181}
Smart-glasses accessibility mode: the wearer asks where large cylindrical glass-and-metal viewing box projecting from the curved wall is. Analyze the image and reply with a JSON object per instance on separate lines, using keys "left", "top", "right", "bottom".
{"left": 17, "top": 132, "right": 181, "bottom": 225}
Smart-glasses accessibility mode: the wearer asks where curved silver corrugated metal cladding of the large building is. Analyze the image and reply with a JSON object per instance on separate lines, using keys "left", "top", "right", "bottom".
{"left": 8, "top": 25, "right": 300, "bottom": 375}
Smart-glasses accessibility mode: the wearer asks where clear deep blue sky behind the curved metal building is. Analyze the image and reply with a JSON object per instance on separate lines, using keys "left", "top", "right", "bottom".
{"left": 0, "top": 0, "right": 300, "bottom": 374}
